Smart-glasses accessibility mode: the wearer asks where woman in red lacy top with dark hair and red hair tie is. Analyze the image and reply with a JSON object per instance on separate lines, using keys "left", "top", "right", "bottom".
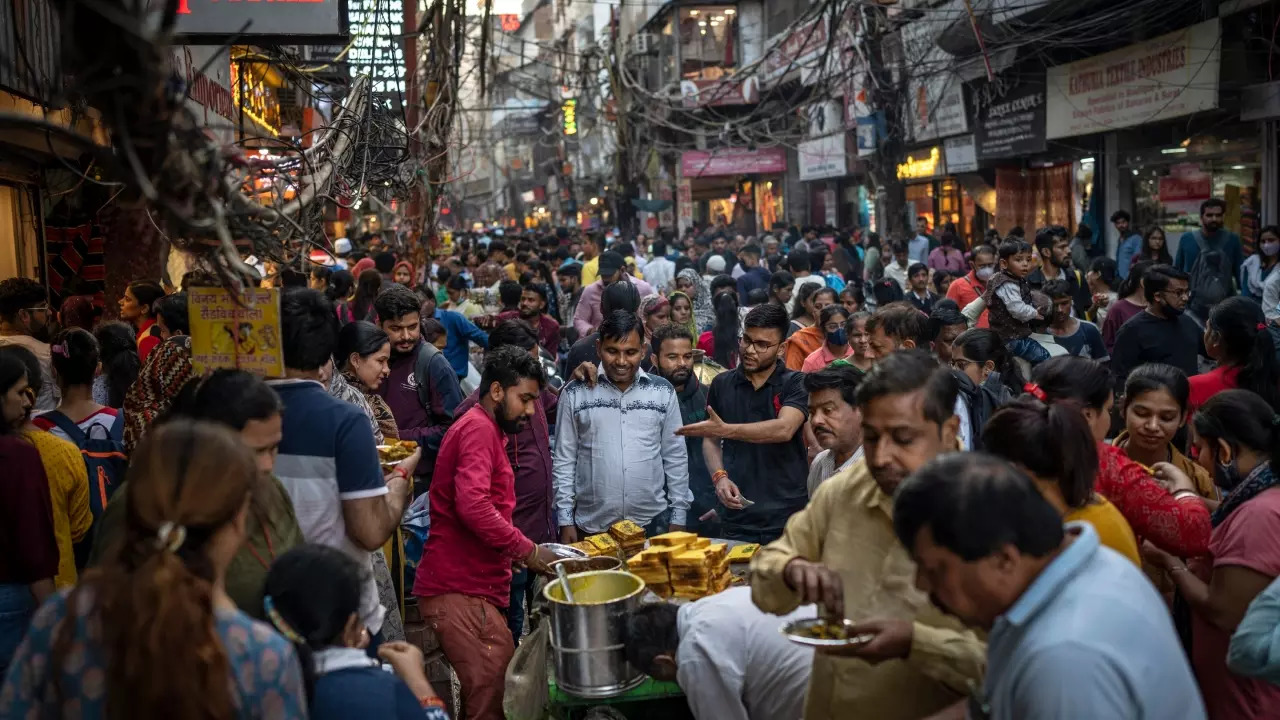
{"left": 1027, "top": 355, "right": 1211, "bottom": 557}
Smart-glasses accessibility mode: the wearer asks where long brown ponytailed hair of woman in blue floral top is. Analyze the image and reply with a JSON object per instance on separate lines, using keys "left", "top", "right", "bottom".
{"left": 50, "top": 420, "right": 257, "bottom": 720}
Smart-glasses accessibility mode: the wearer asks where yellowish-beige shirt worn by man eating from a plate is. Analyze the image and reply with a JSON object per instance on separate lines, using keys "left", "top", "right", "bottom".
{"left": 751, "top": 460, "right": 987, "bottom": 720}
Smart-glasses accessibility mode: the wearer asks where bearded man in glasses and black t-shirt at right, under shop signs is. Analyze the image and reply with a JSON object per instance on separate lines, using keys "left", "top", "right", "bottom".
{"left": 1111, "top": 265, "right": 1204, "bottom": 396}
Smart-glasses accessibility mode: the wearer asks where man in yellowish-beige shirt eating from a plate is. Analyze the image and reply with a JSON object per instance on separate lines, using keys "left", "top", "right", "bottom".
{"left": 751, "top": 351, "right": 986, "bottom": 720}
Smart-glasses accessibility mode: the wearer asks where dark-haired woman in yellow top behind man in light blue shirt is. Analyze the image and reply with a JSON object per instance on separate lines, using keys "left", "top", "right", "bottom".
{"left": 982, "top": 389, "right": 1142, "bottom": 568}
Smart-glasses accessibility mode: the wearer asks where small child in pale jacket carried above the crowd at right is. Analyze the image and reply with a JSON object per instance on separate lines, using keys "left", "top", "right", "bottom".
{"left": 982, "top": 237, "right": 1048, "bottom": 365}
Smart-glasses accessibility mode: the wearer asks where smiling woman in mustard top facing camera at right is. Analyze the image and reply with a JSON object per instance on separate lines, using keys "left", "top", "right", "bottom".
{"left": 1111, "top": 363, "right": 1219, "bottom": 499}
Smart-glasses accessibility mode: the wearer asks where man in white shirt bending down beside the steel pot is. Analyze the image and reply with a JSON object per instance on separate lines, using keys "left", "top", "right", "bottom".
{"left": 626, "top": 587, "right": 817, "bottom": 720}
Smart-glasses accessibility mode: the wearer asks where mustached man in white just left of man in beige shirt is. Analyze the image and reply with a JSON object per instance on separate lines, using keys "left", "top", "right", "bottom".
{"left": 804, "top": 360, "right": 863, "bottom": 497}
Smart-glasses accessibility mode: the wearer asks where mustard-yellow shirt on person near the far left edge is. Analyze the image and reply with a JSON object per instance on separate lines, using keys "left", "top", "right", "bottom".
{"left": 22, "top": 430, "right": 93, "bottom": 588}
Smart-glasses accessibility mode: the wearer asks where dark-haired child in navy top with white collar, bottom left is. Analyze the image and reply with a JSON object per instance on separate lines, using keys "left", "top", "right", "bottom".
{"left": 262, "top": 544, "right": 448, "bottom": 720}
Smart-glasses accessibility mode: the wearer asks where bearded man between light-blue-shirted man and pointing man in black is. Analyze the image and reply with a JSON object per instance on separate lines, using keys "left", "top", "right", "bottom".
{"left": 649, "top": 323, "right": 721, "bottom": 538}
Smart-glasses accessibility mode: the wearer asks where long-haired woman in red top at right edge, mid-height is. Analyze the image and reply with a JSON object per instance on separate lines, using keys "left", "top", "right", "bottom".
{"left": 1190, "top": 296, "right": 1280, "bottom": 413}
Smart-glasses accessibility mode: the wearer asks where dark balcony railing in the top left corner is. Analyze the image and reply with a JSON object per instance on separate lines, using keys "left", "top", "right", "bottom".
{"left": 0, "top": 0, "right": 63, "bottom": 104}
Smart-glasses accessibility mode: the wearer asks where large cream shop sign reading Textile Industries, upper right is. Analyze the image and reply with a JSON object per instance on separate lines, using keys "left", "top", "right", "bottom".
{"left": 1046, "top": 18, "right": 1222, "bottom": 140}
